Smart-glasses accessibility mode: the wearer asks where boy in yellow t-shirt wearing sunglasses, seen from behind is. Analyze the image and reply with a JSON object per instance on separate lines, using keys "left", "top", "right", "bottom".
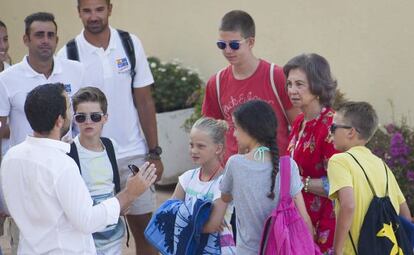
{"left": 328, "top": 102, "right": 411, "bottom": 254}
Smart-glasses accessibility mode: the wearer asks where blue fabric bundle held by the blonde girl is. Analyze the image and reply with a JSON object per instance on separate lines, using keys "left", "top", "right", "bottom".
{"left": 144, "top": 199, "right": 221, "bottom": 255}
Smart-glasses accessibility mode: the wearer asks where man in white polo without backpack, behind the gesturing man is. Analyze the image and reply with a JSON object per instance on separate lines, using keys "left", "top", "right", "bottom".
{"left": 0, "top": 13, "right": 84, "bottom": 253}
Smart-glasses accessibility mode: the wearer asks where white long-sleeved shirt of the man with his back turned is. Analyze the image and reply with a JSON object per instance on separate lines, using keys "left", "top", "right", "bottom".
{"left": 0, "top": 136, "right": 120, "bottom": 254}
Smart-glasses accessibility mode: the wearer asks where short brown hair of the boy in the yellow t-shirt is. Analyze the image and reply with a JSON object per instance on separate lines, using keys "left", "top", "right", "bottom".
{"left": 337, "top": 101, "right": 378, "bottom": 142}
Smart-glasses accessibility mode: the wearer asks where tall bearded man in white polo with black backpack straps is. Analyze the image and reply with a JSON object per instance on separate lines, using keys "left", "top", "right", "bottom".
{"left": 58, "top": 0, "right": 163, "bottom": 255}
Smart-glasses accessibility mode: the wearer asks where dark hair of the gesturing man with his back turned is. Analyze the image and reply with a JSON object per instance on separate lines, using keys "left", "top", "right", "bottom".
{"left": 24, "top": 83, "right": 67, "bottom": 135}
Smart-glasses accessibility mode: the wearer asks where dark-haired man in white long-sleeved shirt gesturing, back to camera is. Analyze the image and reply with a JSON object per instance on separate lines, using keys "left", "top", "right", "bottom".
{"left": 0, "top": 83, "right": 156, "bottom": 255}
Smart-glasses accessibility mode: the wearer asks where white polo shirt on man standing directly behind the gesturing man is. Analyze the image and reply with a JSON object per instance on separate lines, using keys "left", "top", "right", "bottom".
{"left": 0, "top": 56, "right": 84, "bottom": 146}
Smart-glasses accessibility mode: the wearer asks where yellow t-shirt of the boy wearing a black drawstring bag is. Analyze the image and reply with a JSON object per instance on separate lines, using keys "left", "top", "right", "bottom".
{"left": 328, "top": 146, "right": 405, "bottom": 254}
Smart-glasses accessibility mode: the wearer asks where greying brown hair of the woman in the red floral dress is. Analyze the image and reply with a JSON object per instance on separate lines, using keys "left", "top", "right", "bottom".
{"left": 283, "top": 53, "right": 338, "bottom": 106}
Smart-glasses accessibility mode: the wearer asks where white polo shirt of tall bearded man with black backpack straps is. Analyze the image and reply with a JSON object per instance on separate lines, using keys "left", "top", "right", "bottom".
{"left": 57, "top": 27, "right": 154, "bottom": 158}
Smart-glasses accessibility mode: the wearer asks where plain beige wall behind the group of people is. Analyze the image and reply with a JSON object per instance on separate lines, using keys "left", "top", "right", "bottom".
{"left": 0, "top": 0, "right": 414, "bottom": 125}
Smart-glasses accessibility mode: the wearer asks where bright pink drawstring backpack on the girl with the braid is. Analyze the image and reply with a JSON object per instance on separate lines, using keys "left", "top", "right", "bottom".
{"left": 259, "top": 156, "right": 322, "bottom": 255}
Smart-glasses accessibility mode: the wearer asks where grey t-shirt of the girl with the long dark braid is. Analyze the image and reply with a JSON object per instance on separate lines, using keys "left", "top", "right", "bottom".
{"left": 220, "top": 154, "right": 303, "bottom": 255}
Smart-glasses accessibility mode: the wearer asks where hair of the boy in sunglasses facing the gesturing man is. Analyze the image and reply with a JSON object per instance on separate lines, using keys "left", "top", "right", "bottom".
{"left": 72, "top": 87, "right": 108, "bottom": 114}
